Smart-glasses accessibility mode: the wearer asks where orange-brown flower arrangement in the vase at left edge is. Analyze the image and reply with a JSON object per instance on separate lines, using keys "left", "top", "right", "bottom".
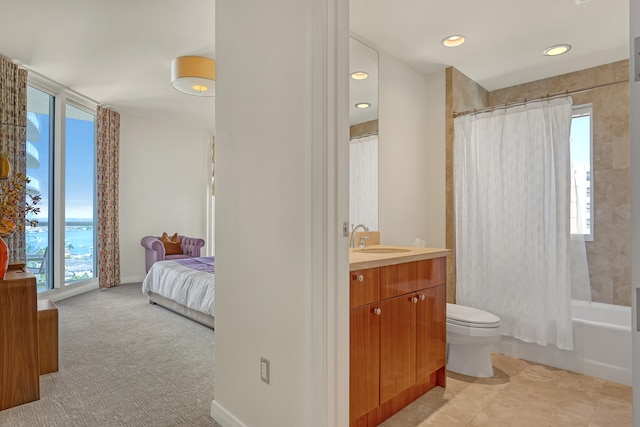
{"left": 0, "top": 173, "right": 40, "bottom": 236}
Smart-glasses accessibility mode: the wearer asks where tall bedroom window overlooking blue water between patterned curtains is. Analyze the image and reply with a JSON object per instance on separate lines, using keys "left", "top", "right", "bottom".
{"left": 26, "top": 80, "right": 97, "bottom": 292}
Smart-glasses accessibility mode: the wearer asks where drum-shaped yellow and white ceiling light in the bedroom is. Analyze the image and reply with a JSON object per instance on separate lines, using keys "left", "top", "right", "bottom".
{"left": 171, "top": 56, "right": 216, "bottom": 96}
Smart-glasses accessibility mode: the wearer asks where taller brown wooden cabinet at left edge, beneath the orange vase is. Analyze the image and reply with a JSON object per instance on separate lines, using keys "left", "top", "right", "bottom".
{"left": 0, "top": 264, "right": 40, "bottom": 411}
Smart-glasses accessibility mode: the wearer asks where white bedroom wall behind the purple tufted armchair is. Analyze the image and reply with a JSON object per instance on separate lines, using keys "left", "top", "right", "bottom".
{"left": 120, "top": 112, "right": 213, "bottom": 283}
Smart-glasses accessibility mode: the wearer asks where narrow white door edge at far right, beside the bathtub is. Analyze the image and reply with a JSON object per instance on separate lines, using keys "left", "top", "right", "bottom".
{"left": 629, "top": 0, "right": 640, "bottom": 426}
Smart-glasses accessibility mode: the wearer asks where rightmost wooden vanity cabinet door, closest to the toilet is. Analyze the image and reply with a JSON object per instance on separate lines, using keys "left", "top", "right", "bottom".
{"left": 416, "top": 285, "right": 447, "bottom": 384}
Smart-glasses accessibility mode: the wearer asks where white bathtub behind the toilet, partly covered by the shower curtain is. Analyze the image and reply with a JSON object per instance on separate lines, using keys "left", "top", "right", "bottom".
{"left": 494, "top": 300, "right": 631, "bottom": 386}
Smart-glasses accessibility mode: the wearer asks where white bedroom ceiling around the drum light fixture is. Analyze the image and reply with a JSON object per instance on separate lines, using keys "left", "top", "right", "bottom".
{"left": 0, "top": 0, "right": 215, "bottom": 134}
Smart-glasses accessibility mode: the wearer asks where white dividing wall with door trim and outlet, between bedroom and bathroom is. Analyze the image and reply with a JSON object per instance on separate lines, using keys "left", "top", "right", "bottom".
{"left": 211, "top": 0, "right": 349, "bottom": 427}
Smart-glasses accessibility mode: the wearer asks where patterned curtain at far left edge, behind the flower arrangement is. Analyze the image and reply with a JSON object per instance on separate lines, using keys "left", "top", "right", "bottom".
{"left": 0, "top": 57, "right": 27, "bottom": 263}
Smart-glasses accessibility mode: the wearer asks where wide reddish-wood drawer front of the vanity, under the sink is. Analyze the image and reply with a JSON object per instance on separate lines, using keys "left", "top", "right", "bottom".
{"left": 380, "top": 257, "right": 446, "bottom": 299}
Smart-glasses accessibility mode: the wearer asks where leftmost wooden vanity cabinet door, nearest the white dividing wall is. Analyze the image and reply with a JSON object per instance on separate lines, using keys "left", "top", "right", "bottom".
{"left": 349, "top": 304, "right": 380, "bottom": 421}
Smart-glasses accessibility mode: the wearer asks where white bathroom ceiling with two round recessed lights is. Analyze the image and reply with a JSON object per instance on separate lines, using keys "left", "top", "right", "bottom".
{"left": 350, "top": 0, "right": 629, "bottom": 90}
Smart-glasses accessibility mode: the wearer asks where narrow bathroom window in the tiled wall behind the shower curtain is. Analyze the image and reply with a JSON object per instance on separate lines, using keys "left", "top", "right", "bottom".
{"left": 570, "top": 105, "right": 593, "bottom": 241}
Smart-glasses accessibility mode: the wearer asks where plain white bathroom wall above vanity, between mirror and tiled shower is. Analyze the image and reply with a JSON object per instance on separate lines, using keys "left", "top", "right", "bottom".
{"left": 379, "top": 52, "right": 446, "bottom": 248}
